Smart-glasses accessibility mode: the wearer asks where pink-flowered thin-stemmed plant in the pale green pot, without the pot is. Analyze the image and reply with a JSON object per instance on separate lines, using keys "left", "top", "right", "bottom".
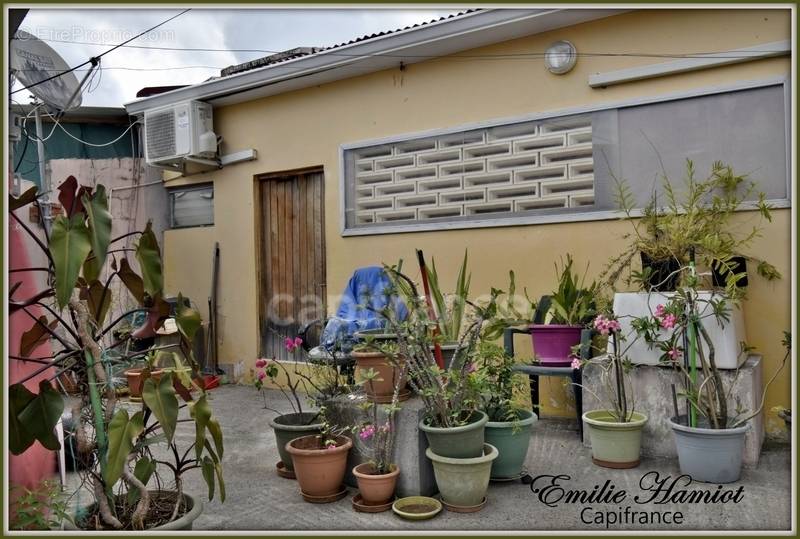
{"left": 572, "top": 313, "right": 635, "bottom": 423}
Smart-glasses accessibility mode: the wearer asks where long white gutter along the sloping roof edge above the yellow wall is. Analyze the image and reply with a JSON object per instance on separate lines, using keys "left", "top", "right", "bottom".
{"left": 125, "top": 8, "right": 628, "bottom": 114}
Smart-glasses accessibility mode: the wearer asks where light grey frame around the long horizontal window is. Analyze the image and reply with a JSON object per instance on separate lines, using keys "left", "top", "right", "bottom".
{"left": 339, "top": 76, "right": 793, "bottom": 237}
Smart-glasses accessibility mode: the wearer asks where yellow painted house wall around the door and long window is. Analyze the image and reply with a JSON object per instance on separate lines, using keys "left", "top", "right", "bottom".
{"left": 159, "top": 9, "right": 791, "bottom": 432}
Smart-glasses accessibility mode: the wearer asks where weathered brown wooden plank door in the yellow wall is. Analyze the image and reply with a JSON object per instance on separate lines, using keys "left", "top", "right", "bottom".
{"left": 259, "top": 169, "right": 326, "bottom": 360}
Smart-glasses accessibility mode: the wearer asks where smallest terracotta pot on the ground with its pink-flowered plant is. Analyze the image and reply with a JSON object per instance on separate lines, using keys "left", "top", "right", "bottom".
{"left": 353, "top": 367, "right": 405, "bottom": 510}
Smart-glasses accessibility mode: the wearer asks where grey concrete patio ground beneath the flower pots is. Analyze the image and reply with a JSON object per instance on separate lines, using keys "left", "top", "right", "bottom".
{"left": 94, "top": 385, "right": 791, "bottom": 532}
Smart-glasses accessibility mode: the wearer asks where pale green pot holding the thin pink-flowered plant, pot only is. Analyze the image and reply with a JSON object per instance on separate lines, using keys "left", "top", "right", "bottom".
{"left": 583, "top": 410, "right": 647, "bottom": 469}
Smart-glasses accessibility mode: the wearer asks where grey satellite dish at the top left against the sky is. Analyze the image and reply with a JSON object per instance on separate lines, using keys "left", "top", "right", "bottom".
{"left": 9, "top": 30, "right": 81, "bottom": 111}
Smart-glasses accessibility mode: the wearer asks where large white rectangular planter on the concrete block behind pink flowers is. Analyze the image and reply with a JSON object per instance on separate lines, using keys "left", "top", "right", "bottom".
{"left": 609, "top": 291, "right": 747, "bottom": 369}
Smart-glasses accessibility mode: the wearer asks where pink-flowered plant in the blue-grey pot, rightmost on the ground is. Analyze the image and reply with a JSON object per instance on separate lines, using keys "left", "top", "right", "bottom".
{"left": 634, "top": 261, "right": 791, "bottom": 483}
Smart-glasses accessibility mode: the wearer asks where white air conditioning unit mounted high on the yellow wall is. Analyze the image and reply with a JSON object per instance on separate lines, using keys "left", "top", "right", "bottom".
{"left": 144, "top": 101, "right": 217, "bottom": 168}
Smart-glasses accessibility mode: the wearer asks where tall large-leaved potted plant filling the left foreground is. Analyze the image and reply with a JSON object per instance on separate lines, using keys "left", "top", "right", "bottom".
{"left": 8, "top": 181, "right": 225, "bottom": 530}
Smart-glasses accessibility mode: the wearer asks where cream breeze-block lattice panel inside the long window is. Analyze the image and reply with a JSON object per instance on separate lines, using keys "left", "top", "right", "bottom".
{"left": 344, "top": 115, "right": 594, "bottom": 228}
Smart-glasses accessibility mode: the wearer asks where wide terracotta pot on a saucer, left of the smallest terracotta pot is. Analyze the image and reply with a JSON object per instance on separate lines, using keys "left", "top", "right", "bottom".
{"left": 286, "top": 435, "right": 353, "bottom": 501}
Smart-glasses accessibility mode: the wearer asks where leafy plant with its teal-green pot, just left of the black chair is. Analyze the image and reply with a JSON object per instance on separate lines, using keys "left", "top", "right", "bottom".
{"left": 475, "top": 340, "right": 538, "bottom": 481}
